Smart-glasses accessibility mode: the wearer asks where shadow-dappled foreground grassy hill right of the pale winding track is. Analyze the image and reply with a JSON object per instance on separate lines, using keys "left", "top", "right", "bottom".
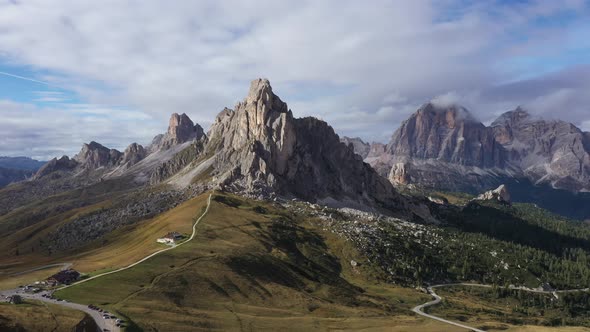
{"left": 57, "top": 194, "right": 449, "bottom": 331}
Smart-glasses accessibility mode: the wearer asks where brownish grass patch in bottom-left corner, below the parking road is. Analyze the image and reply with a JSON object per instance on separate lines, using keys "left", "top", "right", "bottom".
{"left": 0, "top": 301, "right": 89, "bottom": 332}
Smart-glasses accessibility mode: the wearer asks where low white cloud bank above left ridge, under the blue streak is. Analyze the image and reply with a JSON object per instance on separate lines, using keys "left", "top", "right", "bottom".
{"left": 0, "top": 100, "right": 165, "bottom": 160}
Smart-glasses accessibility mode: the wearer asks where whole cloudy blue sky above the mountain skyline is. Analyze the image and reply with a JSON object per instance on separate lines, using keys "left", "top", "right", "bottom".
{"left": 0, "top": 0, "right": 590, "bottom": 160}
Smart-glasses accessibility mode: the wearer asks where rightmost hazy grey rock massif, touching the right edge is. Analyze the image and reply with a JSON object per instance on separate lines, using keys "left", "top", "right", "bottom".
{"left": 492, "top": 108, "right": 590, "bottom": 191}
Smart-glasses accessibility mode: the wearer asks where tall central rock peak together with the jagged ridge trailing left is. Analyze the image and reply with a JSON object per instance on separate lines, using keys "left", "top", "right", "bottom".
{"left": 0, "top": 79, "right": 431, "bottom": 220}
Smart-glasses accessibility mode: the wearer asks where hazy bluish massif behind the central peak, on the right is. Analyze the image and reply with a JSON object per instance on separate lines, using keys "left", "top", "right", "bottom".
{"left": 342, "top": 103, "right": 590, "bottom": 218}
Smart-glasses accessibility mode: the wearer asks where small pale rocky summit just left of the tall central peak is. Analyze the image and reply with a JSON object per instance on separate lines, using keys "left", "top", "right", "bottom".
{"left": 151, "top": 113, "right": 205, "bottom": 150}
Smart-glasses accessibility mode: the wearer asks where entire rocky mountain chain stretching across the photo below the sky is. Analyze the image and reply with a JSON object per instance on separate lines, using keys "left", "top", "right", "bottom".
{"left": 0, "top": 79, "right": 590, "bottom": 220}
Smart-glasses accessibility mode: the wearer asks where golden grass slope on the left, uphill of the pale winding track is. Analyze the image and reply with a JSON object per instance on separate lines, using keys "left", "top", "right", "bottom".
{"left": 0, "top": 189, "right": 207, "bottom": 288}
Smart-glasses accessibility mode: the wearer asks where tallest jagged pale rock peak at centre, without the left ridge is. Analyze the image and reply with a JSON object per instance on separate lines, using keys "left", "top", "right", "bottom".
{"left": 205, "top": 79, "right": 429, "bottom": 218}
